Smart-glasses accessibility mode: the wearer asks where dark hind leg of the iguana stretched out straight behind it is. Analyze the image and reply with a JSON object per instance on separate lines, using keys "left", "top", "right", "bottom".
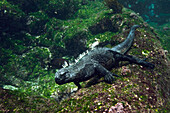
{"left": 120, "top": 55, "right": 155, "bottom": 69}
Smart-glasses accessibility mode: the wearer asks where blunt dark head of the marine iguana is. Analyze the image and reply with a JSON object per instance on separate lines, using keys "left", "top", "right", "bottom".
{"left": 55, "top": 68, "right": 71, "bottom": 85}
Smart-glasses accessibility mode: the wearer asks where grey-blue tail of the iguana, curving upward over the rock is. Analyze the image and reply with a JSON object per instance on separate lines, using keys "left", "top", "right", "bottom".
{"left": 112, "top": 25, "right": 139, "bottom": 54}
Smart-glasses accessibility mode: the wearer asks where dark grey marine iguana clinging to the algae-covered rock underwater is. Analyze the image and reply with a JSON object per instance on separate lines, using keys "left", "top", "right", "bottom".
{"left": 55, "top": 25, "right": 154, "bottom": 89}
